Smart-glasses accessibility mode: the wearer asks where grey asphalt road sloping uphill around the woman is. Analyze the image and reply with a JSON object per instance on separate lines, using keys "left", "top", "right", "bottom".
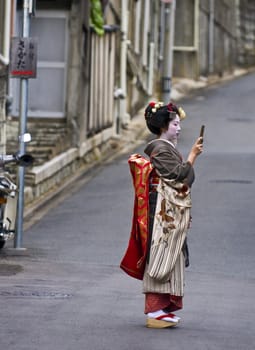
{"left": 0, "top": 74, "right": 255, "bottom": 350}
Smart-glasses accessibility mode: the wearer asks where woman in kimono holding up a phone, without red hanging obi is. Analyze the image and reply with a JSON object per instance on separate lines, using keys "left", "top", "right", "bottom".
{"left": 143, "top": 102, "right": 203, "bottom": 328}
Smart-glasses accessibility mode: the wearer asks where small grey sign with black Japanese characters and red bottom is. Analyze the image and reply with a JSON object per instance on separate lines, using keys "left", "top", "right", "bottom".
{"left": 10, "top": 37, "right": 37, "bottom": 78}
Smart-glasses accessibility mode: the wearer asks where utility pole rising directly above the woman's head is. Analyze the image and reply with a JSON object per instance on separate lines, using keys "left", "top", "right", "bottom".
{"left": 161, "top": 0, "right": 175, "bottom": 104}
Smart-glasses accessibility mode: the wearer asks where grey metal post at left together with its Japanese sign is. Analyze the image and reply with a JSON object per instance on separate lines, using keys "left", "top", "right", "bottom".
{"left": 10, "top": 0, "right": 37, "bottom": 249}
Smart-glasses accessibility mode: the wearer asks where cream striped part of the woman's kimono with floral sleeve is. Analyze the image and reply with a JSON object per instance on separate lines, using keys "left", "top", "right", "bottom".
{"left": 143, "top": 179, "right": 191, "bottom": 296}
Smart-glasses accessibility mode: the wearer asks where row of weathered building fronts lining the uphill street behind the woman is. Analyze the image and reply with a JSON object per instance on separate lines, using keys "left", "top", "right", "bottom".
{"left": 0, "top": 0, "right": 255, "bottom": 204}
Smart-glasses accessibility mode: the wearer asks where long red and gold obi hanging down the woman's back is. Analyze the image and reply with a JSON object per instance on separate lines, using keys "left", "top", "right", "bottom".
{"left": 120, "top": 154, "right": 153, "bottom": 280}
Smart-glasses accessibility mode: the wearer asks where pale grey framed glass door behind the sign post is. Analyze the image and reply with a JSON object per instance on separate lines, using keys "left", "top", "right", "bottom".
{"left": 13, "top": 11, "right": 68, "bottom": 118}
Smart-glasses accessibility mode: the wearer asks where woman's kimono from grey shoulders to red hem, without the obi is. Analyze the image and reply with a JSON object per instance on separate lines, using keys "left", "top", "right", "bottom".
{"left": 143, "top": 139, "right": 194, "bottom": 313}
